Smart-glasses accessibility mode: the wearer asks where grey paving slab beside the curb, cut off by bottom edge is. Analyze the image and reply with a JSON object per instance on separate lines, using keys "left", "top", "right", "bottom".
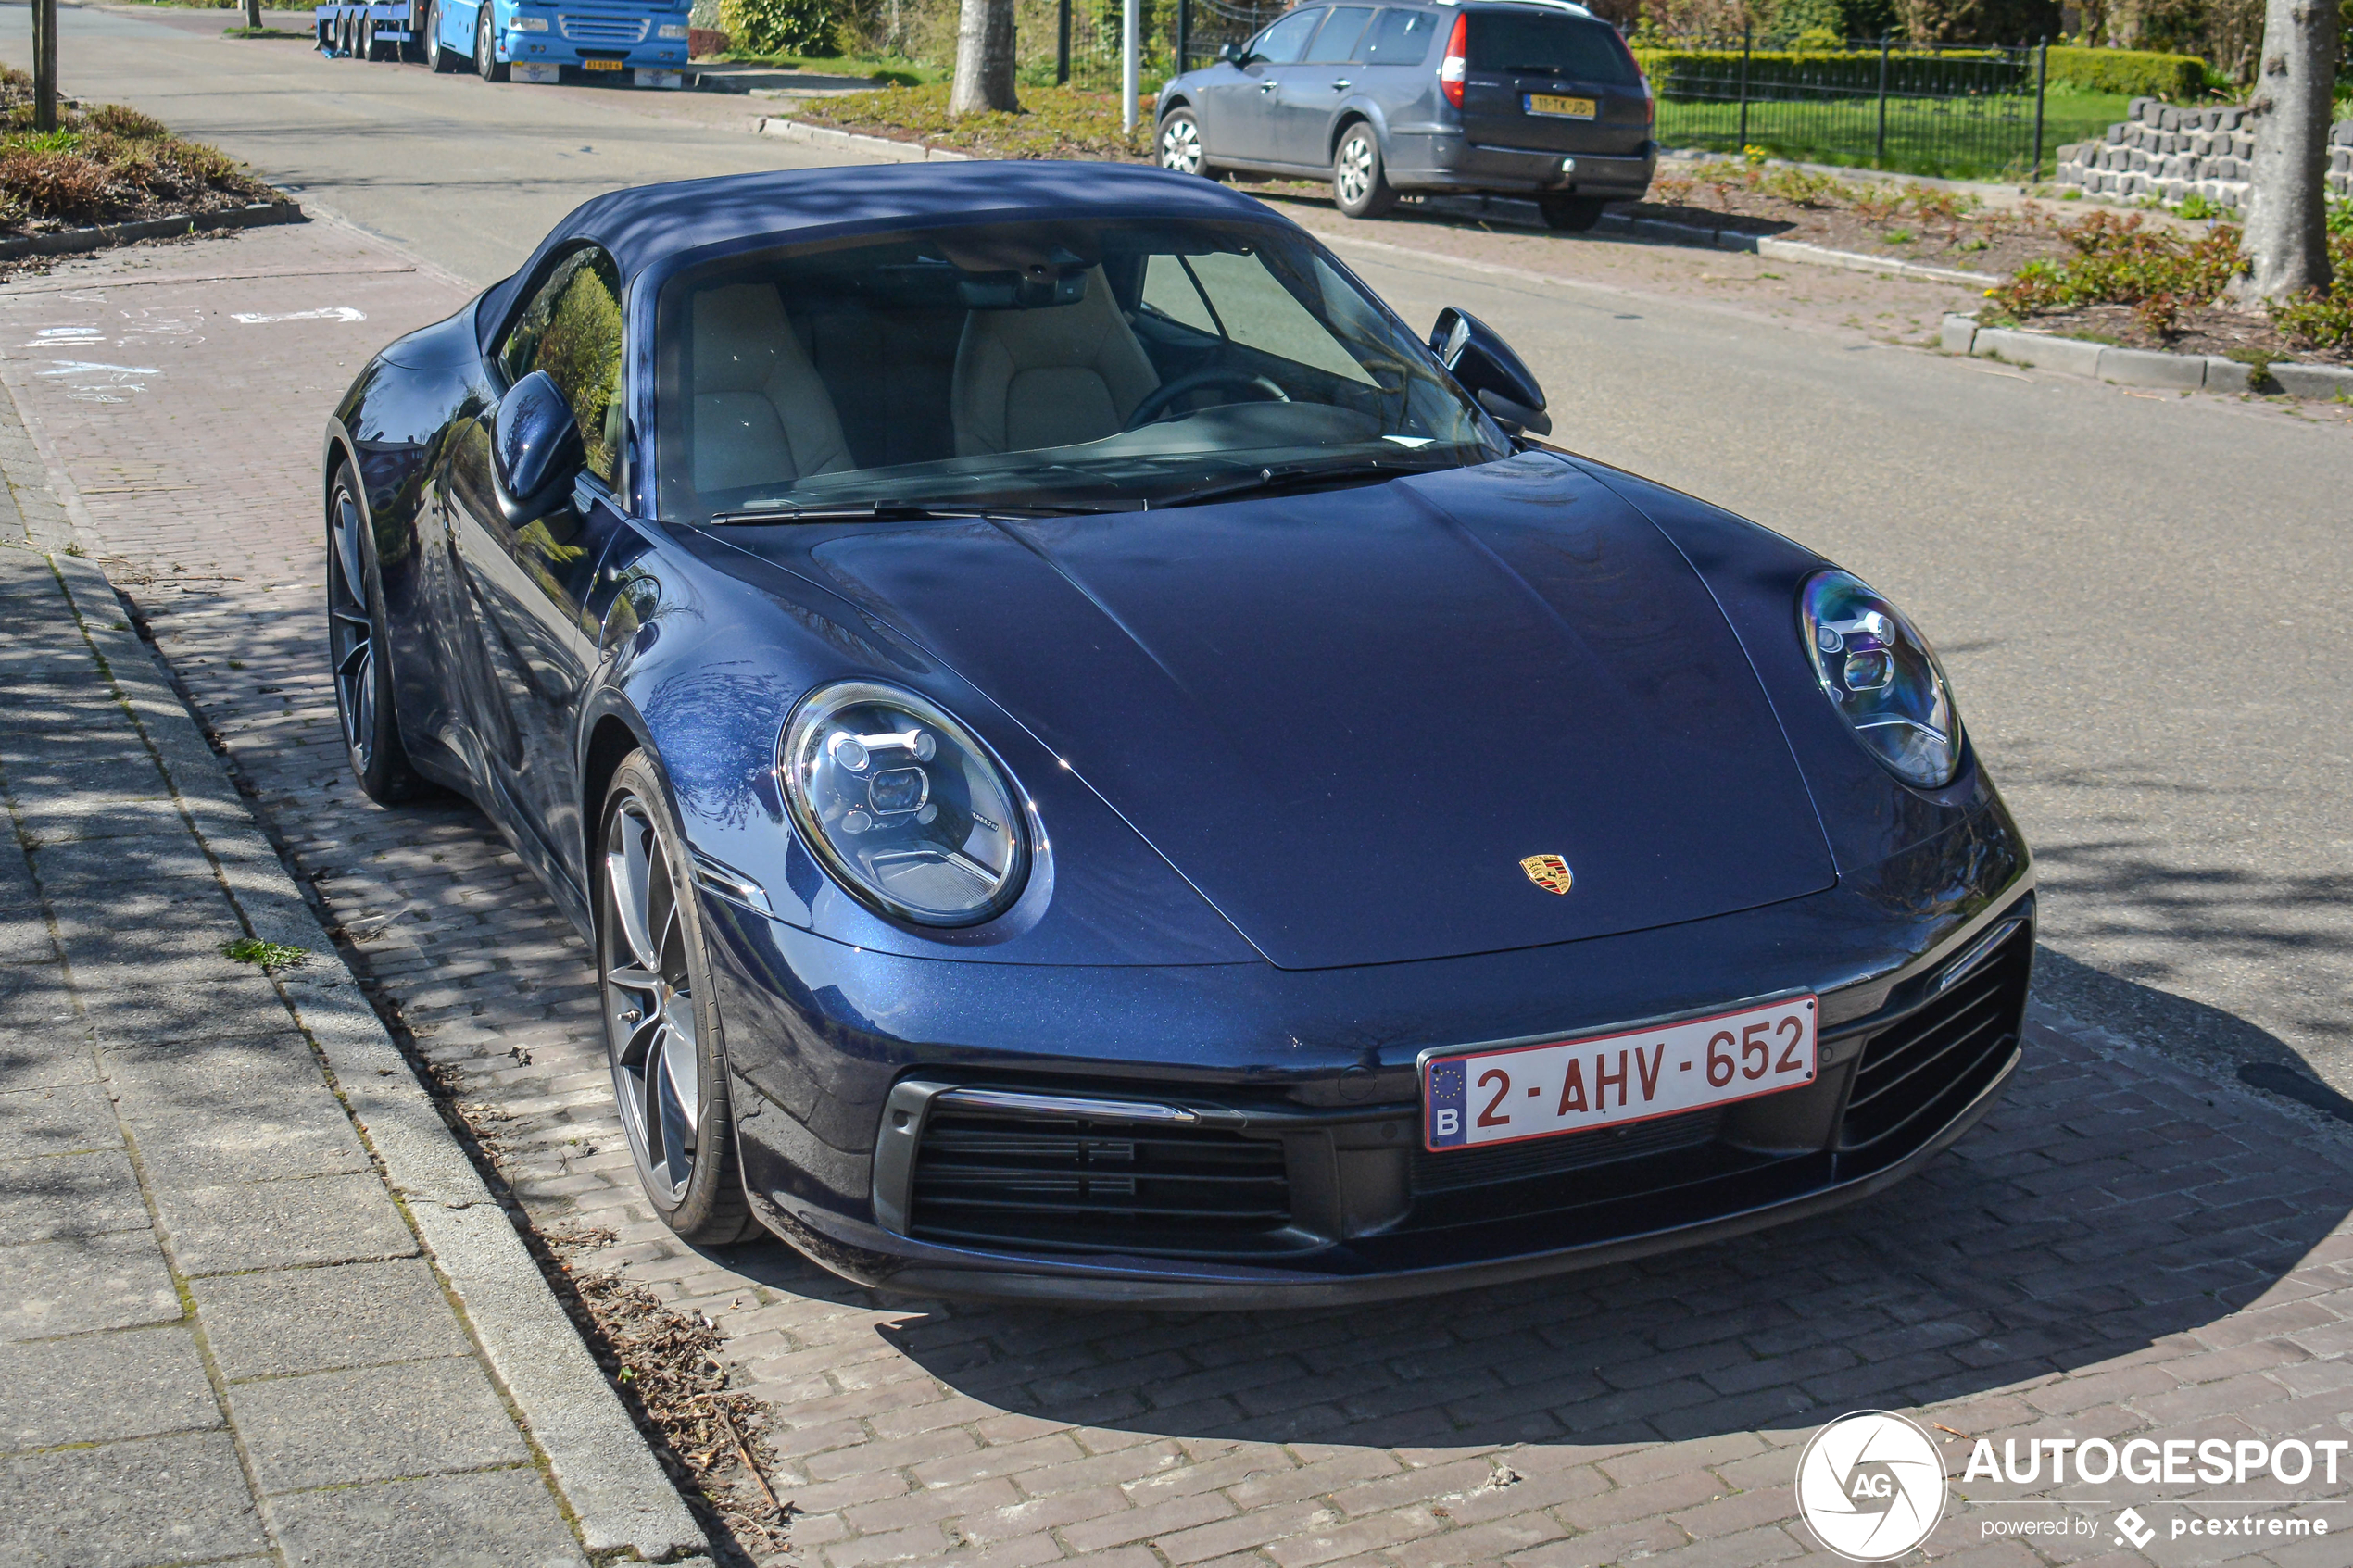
{"left": 269, "top": 1469, "right": 585, "bottom": 1568}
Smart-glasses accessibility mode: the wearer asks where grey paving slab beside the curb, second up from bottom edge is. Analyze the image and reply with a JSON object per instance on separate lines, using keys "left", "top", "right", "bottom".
{"left": 228, "top": 1357, "right": 530, "bottom": 1493}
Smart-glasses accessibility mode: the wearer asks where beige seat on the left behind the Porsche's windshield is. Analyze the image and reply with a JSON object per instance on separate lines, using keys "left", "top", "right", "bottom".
{"left": 692, "top": 282, "right": 857, "bottom": 494}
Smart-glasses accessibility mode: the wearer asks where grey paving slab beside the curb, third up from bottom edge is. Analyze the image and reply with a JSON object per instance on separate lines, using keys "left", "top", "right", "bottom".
{"left": 188, "top": 1258, "right": 471, "bottom": 1382}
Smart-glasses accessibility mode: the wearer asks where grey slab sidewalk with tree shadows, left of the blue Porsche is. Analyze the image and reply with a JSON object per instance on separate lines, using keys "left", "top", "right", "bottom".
{"left": 0, "top": 267, "right": 698, "bottom": 1568}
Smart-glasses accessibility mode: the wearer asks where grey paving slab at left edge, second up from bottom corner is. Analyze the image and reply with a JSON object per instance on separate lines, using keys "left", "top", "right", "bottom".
{"left": 0, "top": 1323, "right": 221, "bottom": 1450}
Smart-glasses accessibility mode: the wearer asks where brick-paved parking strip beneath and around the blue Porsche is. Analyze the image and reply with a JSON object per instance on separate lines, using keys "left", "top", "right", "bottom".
{"left": 13, "top": 226, "right": 2353, "bottom": 1568}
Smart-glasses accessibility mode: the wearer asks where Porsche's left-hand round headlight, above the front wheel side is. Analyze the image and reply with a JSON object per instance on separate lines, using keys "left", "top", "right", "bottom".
{"left": 776, "top": 682, "right": 1028, "bottom": 926}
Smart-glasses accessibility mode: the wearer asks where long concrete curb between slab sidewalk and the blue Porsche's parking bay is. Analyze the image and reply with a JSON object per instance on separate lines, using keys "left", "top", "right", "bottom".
{"left": 9, "top": 369, "right": 711, "bottom": 1561}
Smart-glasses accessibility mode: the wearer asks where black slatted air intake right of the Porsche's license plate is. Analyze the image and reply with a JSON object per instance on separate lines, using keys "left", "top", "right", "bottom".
{"left": 1838, "top": 926, "right": 2035, "bottom": 1149}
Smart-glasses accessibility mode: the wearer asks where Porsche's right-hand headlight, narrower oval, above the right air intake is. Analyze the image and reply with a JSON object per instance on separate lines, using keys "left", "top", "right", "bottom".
{"left": 1798, "top": 571, "right": 1960, "bottom": 790}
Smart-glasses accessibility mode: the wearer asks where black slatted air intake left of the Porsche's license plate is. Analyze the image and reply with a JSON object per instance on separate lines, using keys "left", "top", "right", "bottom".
{"left": 911, "top": 1105, "right": 1308, "bottom": 1255}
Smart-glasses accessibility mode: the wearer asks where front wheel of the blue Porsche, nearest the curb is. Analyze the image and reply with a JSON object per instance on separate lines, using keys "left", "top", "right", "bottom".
{"left": 591, "top": 750, "right": 760, "bottom": 1246}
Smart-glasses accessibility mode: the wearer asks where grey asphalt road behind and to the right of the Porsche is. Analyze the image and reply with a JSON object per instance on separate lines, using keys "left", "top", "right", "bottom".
{"left": 18, "top": 7, "right": 2353, "bottom": 1091}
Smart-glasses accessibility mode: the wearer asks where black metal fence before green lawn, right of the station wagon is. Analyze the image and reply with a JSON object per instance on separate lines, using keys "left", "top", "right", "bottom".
{"left": 1642, "top": 35, "right": 2045, "bottom": 176}
